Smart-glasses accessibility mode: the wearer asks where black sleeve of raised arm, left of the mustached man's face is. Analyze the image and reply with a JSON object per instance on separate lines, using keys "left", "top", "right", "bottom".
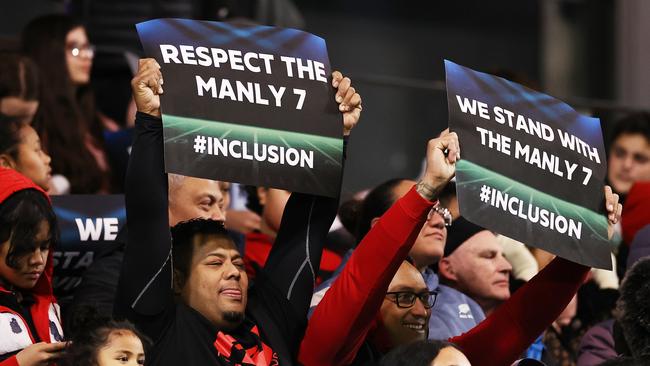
{"left": 114, "top": 113, "right": 174, "bottom": 340}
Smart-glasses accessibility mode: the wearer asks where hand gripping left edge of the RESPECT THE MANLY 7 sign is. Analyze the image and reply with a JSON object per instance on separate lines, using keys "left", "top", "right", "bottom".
{"left": 131, "top": 58, "right": 163, "bottom": 118}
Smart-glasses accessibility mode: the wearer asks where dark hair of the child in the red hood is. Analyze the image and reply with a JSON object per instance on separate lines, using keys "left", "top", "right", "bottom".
{"left": 0, "top": 189, "right": 59, "bottom": 268}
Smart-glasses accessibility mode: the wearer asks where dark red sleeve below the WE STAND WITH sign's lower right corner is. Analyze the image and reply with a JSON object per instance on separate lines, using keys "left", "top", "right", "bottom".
{"left": 450, "top": 257, "right": 589, "bottom": 366}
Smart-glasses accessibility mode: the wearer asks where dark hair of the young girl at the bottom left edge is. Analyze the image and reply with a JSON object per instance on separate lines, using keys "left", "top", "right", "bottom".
{"left": 61, "top": 306, "right": 151, "bottom": 366}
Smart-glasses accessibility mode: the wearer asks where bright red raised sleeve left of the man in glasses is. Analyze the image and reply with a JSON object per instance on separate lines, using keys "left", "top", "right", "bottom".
{"left": 298, "top": 187, "right": 433, "bottom": 366}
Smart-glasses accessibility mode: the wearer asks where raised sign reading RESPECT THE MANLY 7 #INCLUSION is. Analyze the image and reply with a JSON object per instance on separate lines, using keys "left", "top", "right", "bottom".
{"left": 137, "top": 19, "right": 343, "bottom": 196}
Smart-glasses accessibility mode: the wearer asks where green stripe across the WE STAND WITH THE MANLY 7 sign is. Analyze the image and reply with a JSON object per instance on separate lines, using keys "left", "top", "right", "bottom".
{"left": 456, "top": 160, "right": 608, "bottom": 241}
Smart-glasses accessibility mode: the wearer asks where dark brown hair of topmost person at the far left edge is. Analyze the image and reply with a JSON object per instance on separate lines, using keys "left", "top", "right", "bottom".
{"left": 0, "top": 52, "right": 38, "bottom": 100}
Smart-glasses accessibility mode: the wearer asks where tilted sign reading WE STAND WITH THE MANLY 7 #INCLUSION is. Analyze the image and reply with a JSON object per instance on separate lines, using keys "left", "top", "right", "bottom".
{"left": 445, "top": 61, "right": 612, "bottom": 269}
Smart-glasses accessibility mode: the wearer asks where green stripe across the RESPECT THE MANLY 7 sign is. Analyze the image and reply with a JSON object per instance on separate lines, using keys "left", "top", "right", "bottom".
{"left": 163, "top": 114, "right": 343, "bottom": 167}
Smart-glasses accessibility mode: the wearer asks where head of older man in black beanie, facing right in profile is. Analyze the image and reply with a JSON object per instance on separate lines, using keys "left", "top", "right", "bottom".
{"left": 438, "top": 217, "right": 512, "bottom": 316}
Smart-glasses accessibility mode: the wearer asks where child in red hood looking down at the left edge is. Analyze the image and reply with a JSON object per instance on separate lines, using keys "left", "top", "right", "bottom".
{"left": 0, "top": 167, "right": 65, "bottom": 366}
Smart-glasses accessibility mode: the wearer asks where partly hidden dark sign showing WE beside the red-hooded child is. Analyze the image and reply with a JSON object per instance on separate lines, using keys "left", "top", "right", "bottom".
{"left": 52, "top": 195, "right": 126, "bottom": 302}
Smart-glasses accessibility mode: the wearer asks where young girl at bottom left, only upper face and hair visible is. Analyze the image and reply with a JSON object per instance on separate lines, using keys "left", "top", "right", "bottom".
{"left": 60, "top": 307, "right": 148, "bottom": 366}
